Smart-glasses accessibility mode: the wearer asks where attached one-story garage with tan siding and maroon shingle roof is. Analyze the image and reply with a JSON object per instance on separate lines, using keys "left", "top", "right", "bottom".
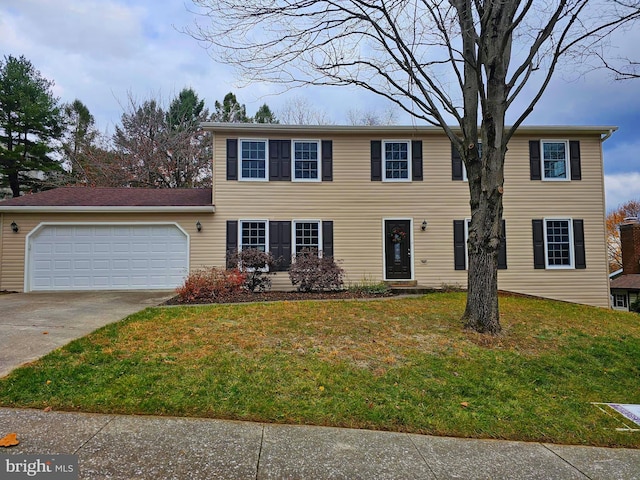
{"left": 0, "top": 187, "right": 216, "bottom": 292}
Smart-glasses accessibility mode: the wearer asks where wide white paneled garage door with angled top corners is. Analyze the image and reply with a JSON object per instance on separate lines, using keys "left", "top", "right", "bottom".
{"left": 28, "top": 225, "right": 189, "bottom": 291}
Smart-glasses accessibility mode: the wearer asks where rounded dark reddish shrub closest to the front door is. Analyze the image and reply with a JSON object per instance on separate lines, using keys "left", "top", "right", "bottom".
{"left": 289, "top": 249, "right": 344, "bottom": 292}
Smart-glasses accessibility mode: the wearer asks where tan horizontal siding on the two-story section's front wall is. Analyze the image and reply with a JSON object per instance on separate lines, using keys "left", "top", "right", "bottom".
{"left": 211, "top": 130, "right": 609, "bottom": 307}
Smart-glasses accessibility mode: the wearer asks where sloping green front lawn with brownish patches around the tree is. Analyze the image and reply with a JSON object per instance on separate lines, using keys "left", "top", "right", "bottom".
{"left": 0, "top": 293, "right": 640, "bottom": 448}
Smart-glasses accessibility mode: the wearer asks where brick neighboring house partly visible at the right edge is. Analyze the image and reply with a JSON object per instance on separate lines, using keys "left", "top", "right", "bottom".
{"left": 611, "top": 218, "right": 640, "bottom": 311}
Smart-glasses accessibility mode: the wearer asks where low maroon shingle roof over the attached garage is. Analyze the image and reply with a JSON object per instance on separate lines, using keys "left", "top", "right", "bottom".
{"left": 0, "top": 187, "right": 213, "bottom": 212}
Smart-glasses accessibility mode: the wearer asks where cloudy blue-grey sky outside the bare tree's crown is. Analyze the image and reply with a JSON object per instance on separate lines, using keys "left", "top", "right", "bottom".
{"left": 0, "top": 0, "right": 640, "bottom": 211}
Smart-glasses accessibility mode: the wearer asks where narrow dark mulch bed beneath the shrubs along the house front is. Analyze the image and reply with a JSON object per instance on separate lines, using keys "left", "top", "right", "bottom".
{"left": 163, "top": 290, "right": 394, "bottom": 305}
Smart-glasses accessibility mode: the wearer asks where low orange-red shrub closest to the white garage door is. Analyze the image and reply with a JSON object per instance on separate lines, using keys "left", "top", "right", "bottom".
{"left": 176, "top": 267, "right": 246, "bottom": 302}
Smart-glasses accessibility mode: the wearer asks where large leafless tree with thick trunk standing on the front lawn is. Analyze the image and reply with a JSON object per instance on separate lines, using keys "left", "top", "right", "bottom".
{"left": 190, "top": 0, "right": 640, "bottom": 334}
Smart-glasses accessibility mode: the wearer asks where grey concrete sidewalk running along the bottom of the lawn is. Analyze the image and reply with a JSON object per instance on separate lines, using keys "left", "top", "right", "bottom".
{"left": 0, "top": 408, "right": 640, "bottom": 480}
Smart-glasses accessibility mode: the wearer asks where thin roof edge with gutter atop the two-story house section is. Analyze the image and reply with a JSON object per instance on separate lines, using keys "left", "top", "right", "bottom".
{"left": 202, "top": 122, "right": 618, "bottom": 139}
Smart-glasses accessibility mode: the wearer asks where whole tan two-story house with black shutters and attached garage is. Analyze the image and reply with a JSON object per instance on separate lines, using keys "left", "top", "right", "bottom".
{"left": 0, "top": 123, "right": 615, "bottom": 307}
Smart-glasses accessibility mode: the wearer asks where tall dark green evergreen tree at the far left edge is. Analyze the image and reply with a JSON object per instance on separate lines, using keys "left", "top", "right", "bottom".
{"left": 0, "top": 55, "right": 63, "bottom": 197}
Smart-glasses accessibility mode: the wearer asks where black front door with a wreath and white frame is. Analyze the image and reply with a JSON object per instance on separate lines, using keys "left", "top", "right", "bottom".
{"left": 384, "top": 220, "right": 411, "bottom": 280}
